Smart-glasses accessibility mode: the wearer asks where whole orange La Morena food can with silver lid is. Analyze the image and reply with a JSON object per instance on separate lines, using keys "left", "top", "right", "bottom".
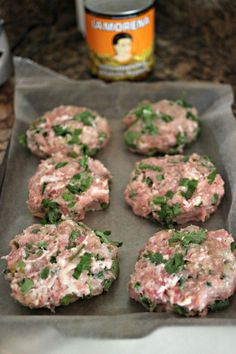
{"left": 85, "top": 0, "right": 155, "bottom": 81}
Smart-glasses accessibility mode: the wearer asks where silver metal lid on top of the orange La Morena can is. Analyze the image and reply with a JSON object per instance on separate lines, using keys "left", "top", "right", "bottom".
{"left": 85, "top": 0, "right": 155, "bottom": 17}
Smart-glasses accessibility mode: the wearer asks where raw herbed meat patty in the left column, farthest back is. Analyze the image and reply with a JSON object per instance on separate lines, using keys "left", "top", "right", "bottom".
{"left": 26, "top": 106, "right": 110, "bottom": 157}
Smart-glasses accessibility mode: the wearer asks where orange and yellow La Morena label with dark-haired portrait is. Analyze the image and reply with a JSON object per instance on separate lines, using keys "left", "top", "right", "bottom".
{"left": 86, "top": 8, "right": 155, "bottom": 80}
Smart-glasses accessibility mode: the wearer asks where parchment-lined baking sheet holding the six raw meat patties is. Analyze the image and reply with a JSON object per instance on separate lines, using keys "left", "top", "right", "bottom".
{"left": 0, "top": 58, "right": 236, "bottom": 338}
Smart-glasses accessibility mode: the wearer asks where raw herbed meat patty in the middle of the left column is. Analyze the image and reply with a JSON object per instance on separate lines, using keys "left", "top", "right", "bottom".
{"left": 28, "top": 153, "right": 111, "bottom": 223}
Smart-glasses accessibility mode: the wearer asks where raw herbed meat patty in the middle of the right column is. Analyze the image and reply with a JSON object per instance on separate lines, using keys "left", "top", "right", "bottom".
{"left": 125, "top": 154, "right": 224, "bottom": 225}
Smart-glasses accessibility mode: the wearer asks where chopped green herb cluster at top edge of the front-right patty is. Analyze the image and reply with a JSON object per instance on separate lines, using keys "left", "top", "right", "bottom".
{"left": 169, "top": 229, "right": 207, "bottom": 247}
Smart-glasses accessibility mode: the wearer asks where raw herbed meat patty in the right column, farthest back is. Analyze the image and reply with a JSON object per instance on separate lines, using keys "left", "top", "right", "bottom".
{"left": 123, "top": 100, "right": 199, "bottom": 155}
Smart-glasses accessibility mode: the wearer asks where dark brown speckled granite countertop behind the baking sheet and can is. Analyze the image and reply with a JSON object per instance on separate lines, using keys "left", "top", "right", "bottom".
{"left": 0, "top": 0, "right": 236, "bottom": 164}
